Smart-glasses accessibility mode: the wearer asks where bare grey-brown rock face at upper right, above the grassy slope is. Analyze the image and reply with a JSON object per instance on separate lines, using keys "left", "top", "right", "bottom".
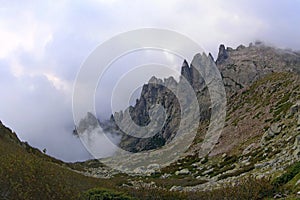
{"left": 216, "top": 44, "right": 300, "bottom": 92}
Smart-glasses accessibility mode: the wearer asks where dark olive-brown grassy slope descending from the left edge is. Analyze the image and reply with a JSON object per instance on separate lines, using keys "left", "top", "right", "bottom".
{"left": 0, "top": 125, "right": 118, "bottom": 199}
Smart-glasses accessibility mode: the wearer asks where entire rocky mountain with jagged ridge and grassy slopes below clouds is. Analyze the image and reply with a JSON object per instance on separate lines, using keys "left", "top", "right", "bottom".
{"left": 0, "top": 42, "right": 300, "bottom": 199}
